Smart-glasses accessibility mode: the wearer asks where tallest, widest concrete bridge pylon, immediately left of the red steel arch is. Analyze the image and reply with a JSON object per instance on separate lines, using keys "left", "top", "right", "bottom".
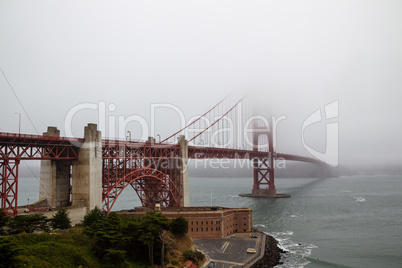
{"left": 72, "top": 124, "right": 102, "bottom": 210}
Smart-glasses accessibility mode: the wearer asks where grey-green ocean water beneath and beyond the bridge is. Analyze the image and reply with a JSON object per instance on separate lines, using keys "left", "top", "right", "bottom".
{"left": 19, "top": 175, "right": 402, "bottom": 268}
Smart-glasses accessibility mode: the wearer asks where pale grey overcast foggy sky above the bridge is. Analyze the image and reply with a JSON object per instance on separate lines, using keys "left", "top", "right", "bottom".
{"left": 0, "top": 0, "right": 402, "bottom": 168}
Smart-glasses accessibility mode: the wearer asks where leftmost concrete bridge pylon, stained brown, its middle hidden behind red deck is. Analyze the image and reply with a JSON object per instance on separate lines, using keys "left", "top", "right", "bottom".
{"left": 39, "top": 127, "right": 71, "bottom": 207}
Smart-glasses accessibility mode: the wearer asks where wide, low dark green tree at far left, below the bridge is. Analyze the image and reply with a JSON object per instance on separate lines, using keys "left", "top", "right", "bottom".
{"left": 7, "top": 213, "right": 49, "bottom": 233}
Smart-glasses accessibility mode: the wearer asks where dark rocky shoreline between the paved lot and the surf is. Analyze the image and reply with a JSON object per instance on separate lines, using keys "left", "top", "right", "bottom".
{"left": 251, "top": 234, "right": 285, "bottom": 268}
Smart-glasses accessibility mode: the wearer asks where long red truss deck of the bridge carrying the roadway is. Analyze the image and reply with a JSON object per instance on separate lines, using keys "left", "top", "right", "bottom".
{"left": 0, "top": 132, "right": 325, "bottom": 165}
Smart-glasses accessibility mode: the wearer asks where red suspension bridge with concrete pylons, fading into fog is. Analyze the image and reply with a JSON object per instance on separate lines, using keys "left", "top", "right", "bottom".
{"left": 0, "top": 96, "right": 330, "bottom": 215}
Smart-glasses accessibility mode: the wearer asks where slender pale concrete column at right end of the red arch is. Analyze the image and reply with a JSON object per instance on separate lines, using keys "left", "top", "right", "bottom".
{"left": 179, "top": 136, "right": 190, "bottom": 207}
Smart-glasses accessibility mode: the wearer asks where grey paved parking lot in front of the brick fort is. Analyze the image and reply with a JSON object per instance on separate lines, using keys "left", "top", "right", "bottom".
{"left": 194, "top": 233, "right": 262, "bottom": 268}
